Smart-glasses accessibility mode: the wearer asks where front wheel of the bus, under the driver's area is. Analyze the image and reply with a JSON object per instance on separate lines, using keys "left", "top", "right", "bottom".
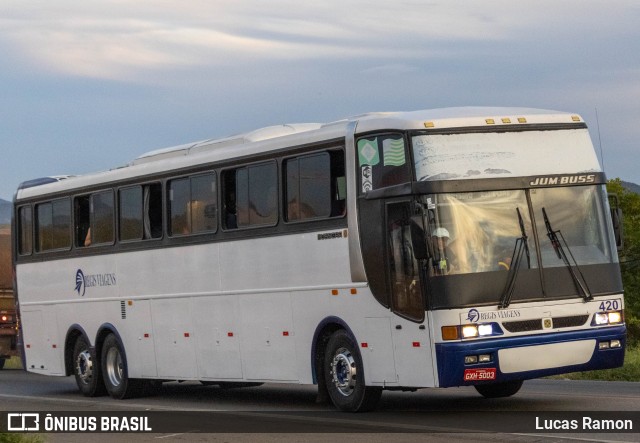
{"left": 324, "top": 329, "right": 382, "bottom": 412}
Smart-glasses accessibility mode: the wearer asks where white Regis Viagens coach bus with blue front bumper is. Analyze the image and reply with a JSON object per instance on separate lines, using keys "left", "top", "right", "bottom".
{"left": 14, "top": 108, "right": 626, "bottom": 411}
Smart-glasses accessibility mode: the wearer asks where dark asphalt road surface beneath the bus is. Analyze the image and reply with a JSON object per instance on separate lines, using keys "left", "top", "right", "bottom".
{"left": 0, "top": 370, "right": 640, "bottom": 443}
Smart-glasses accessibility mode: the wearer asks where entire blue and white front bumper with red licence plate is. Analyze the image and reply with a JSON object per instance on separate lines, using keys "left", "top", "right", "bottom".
{"left": 436, "top": 325, "right": 626, "bottom": 387}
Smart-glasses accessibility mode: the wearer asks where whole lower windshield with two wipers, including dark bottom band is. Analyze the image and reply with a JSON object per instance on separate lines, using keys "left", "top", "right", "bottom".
{"left": 420, "top": 186, "right": 621, "bottom": 306}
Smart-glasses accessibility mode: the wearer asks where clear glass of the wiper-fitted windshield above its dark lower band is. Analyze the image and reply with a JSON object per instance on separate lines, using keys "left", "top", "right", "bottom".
{"left": 424, "top": 186, "right": 617, "bottom": 274}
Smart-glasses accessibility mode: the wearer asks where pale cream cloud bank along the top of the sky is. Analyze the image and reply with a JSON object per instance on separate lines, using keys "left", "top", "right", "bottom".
{"left": 0, "top": 0, "right": 576, "bottom": 81}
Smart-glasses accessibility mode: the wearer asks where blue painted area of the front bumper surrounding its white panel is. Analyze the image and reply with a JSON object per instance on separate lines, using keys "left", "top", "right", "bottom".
{"left": 436, "top": 326, "right": 626, "bottom": 387}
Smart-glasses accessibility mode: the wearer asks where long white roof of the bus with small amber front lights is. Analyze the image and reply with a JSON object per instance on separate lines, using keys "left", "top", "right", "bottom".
{"left": 16, "top": 107, "right": 584, "bottom": 200}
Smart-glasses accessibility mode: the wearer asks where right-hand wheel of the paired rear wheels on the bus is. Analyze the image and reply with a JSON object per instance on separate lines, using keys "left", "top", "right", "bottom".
{"left": 101, "top": 334, "right": 145, "bottom": 400}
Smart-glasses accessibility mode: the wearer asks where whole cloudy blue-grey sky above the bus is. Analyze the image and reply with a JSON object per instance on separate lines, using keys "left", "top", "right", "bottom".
{"left": 0, "top": 0, "right": 640, "bottom": 200}
